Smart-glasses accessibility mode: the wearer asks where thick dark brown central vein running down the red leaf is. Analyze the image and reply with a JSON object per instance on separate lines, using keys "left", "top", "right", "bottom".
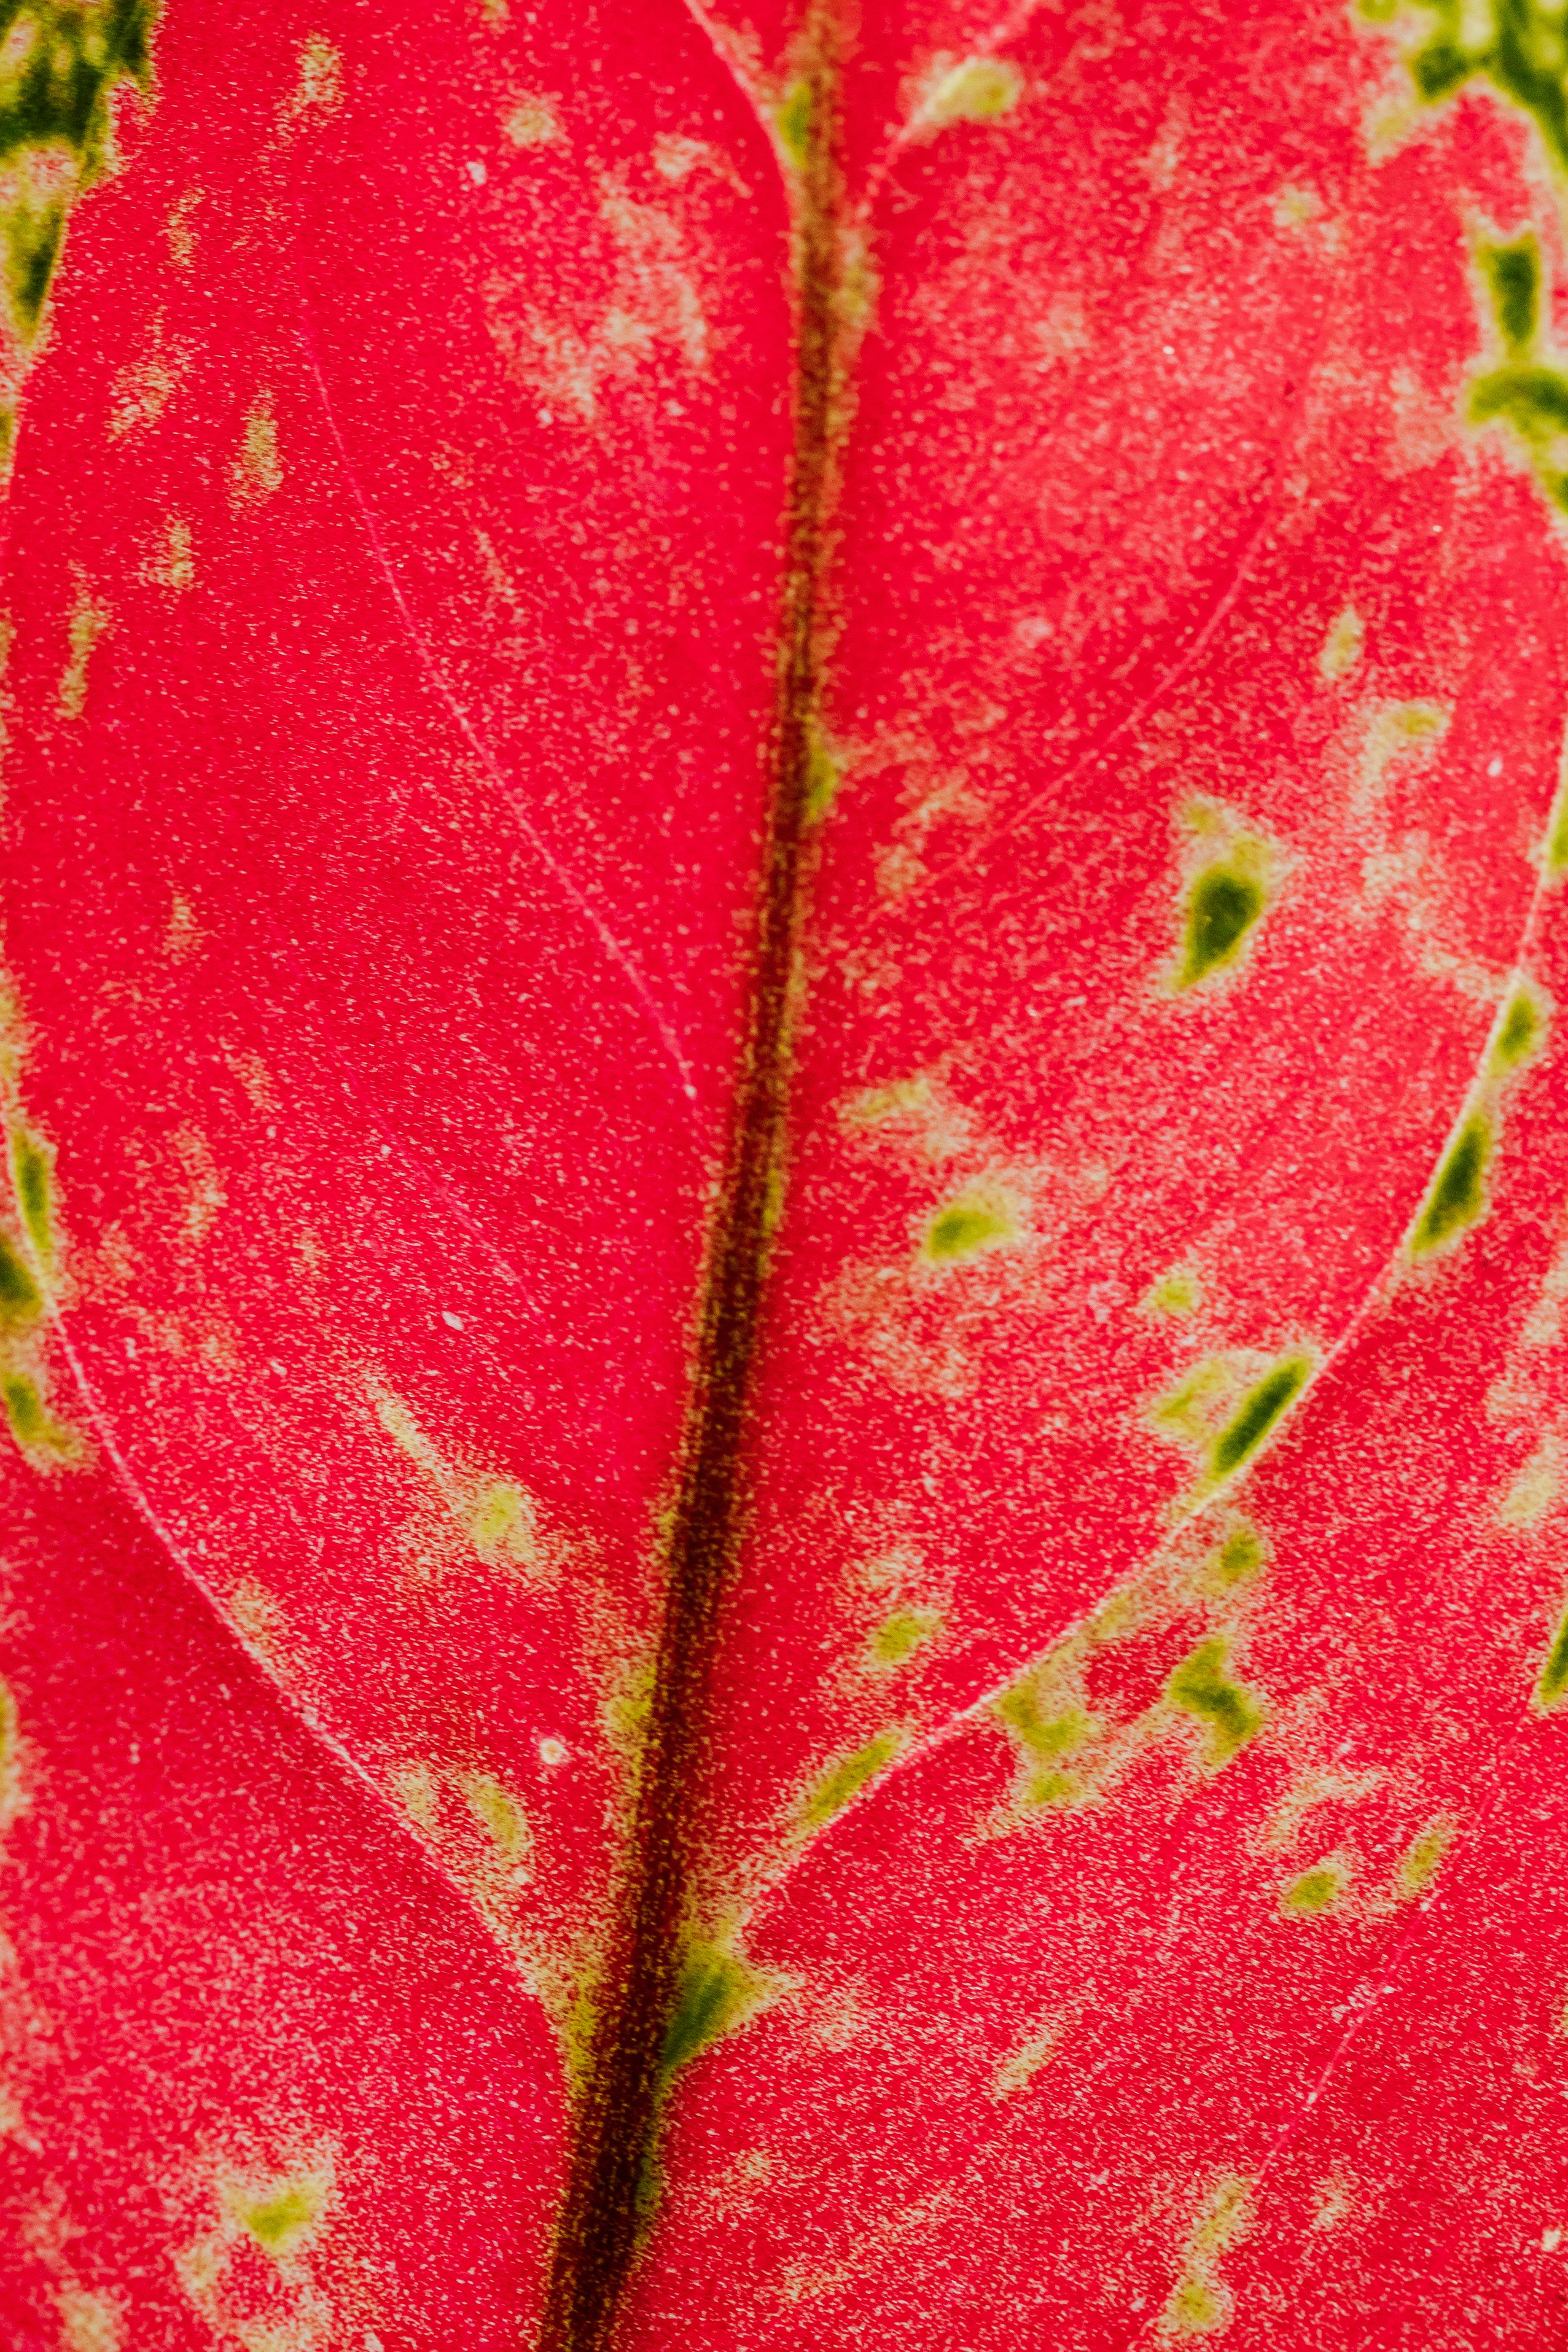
{"left": 541, "top": 32, "right": 839, "bottom": 2352}
